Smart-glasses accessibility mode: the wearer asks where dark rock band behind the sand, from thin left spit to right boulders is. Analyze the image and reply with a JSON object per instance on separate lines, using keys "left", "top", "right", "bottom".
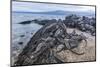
{"left": 19, "top": 14, "right": 96, "bottom": 36}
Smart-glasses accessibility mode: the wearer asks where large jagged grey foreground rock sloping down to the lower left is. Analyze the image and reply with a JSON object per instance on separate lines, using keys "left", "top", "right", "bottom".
{"left": 15, "top": 21, "right": 85, "bottom": 66}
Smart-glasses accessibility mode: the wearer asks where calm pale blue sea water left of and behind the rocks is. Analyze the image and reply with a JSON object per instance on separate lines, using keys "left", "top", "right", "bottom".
{"left": 12, "top": 13, "right": 65, "bottom": 40}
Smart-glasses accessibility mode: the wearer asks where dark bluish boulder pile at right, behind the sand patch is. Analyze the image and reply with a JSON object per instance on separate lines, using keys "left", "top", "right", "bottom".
{"left": 63, "top": 15, "right": 96, "bottom": 36}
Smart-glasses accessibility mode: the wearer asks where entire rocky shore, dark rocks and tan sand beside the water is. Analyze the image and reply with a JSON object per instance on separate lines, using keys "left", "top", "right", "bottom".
{"left": 12, "top": 15, "right": 96, "bottom": 66}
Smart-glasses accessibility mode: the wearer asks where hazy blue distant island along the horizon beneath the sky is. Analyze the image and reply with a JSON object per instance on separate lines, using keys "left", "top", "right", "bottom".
{"left": 13, "top": 10, "right": 95, "bottom": 17}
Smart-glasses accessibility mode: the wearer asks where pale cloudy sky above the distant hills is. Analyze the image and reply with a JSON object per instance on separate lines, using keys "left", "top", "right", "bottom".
{"left": 12, "top": 1, "right": 95, "bottom": 12}
